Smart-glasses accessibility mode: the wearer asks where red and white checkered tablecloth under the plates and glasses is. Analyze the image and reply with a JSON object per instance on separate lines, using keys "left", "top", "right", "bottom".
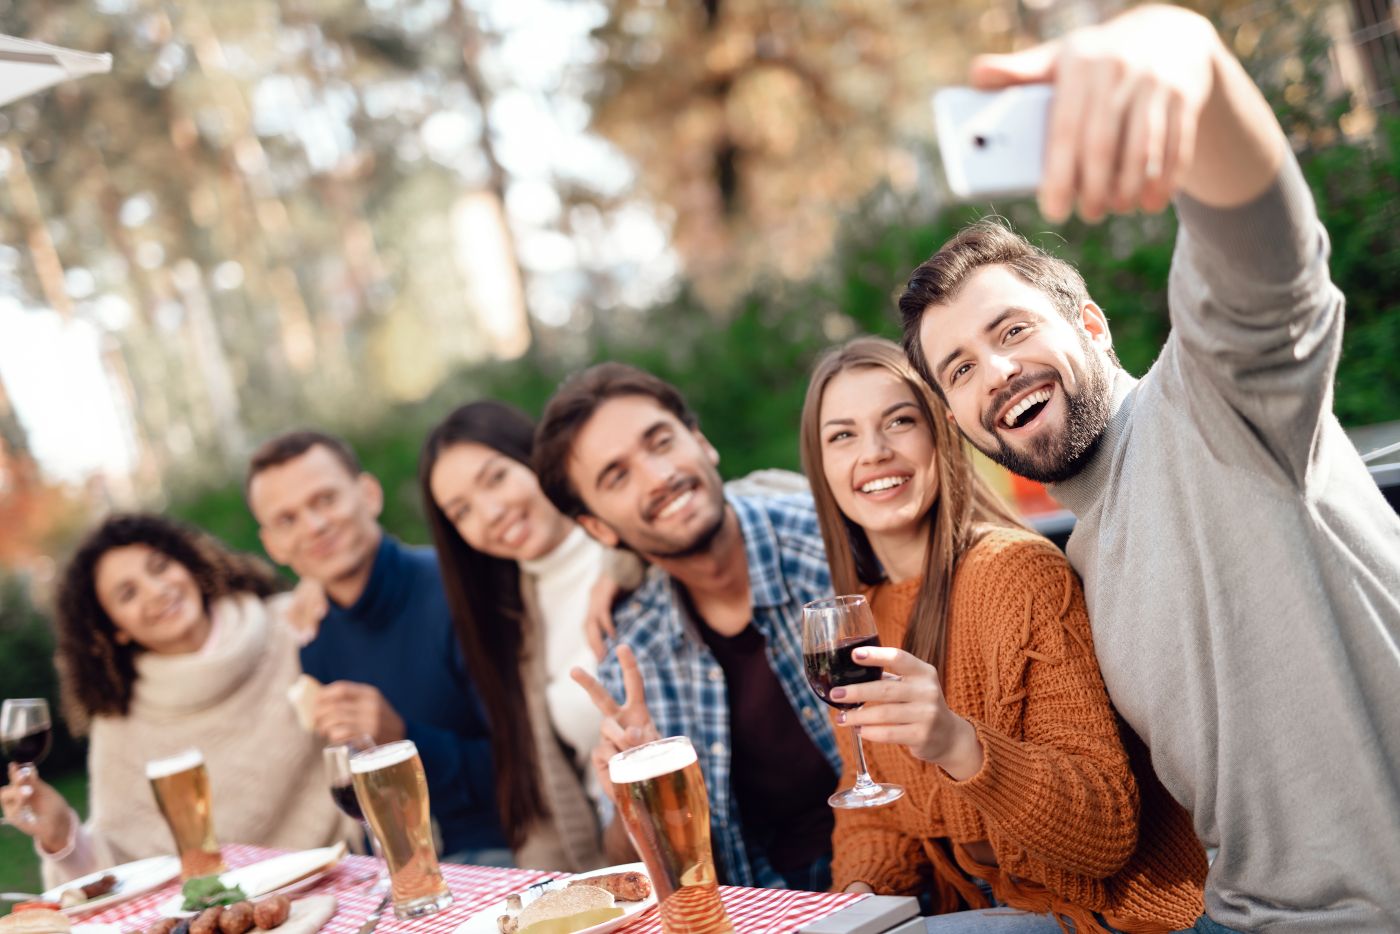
{"left": 78, "top": 844, "right": 865, "bottom": 934}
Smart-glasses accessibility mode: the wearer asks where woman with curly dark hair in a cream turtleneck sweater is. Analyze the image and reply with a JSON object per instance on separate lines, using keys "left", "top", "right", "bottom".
{"left": 0, "top": 515, "right": 356, "bottom": 884}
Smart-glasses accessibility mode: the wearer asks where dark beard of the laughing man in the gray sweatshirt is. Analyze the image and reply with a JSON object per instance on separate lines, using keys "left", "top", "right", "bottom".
{"left": 969, "top": 347, "right": 1113, "bottom": 483}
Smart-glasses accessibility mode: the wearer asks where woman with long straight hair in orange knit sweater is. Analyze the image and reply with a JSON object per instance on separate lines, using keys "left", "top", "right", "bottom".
{"left": 802, "top": 337, "right": 1207, "bottom": 934}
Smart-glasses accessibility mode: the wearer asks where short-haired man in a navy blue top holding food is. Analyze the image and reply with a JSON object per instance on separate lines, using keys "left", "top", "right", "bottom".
{"left": 245, "top": 431, "right": 511, "bottom": 865}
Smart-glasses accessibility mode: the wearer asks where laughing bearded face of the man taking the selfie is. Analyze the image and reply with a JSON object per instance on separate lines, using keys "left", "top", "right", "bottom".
{"left": 918, "top": 265, "right": 1112, "bottom": 483}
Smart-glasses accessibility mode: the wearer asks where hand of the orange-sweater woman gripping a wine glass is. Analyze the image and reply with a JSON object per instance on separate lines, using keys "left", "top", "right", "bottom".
{"left": 832, "top": 646, "right": 983, "bottom": 781}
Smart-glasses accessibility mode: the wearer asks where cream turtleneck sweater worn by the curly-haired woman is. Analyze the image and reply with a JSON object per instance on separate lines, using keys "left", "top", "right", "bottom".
{"left": 41, "top": 595, "right": 358, "bottom": 885}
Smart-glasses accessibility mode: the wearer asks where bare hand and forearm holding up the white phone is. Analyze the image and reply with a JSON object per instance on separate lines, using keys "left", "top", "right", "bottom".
{"left": 972, "top": 6, "right": 1285, "bottom": 221}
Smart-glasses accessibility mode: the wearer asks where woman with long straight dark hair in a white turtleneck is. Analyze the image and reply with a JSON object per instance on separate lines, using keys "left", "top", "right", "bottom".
{"left": 419, "top": 400, "right": 640, "bottom": 871}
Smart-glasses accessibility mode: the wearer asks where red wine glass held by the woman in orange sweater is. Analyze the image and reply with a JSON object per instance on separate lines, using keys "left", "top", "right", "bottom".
{"left": 802, "top": 594, "right": 904, "bottom": 808}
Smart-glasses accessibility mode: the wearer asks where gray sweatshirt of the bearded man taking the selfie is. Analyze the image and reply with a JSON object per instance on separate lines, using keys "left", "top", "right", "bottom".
{"left": 1053, "top": 149, "right": 1400, "bottom": 934}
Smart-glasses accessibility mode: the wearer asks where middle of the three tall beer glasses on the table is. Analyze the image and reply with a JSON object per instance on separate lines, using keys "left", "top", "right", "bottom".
{"left": 350, "top": 739, "right": 452, "bottom": 919}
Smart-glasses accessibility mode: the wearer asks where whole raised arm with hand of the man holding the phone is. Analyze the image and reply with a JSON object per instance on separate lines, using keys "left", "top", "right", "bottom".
{"left": 972, "top": 6, "right": 1343, "bottom": 486}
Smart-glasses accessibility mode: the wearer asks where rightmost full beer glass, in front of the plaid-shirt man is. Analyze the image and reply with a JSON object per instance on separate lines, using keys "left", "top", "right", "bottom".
{"left": 608, "top": 737, "right": 734, "bottom": 934}
